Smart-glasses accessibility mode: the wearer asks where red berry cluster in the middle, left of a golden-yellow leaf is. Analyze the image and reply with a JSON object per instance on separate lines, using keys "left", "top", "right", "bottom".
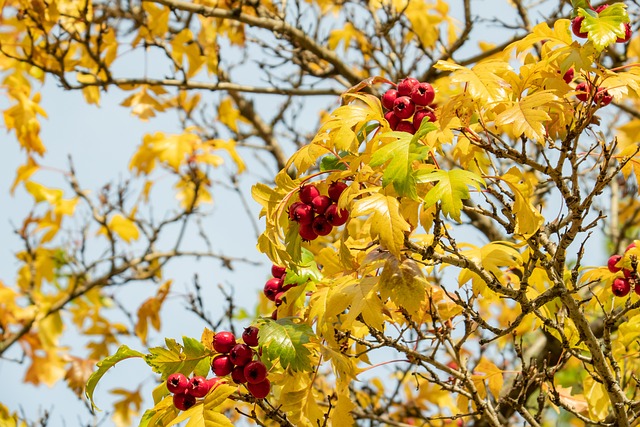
{"left": 290, "top": 181, "right": 349, "bottom": 241}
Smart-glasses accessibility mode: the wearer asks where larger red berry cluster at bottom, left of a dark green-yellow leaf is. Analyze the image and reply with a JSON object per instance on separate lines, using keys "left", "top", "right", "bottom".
{"left": 211, "top": 326, "right": 271, "bottom": 399}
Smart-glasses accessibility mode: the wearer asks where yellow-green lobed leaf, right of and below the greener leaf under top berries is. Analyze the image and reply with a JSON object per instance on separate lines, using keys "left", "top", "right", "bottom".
{"left": 418, "top": 169, "right": 485, "bottom": 222}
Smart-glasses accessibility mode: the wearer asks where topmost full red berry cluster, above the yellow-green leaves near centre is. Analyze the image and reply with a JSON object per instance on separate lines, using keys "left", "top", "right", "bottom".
{"left": 382, "top": 77, "right": 436, "bottom": 134}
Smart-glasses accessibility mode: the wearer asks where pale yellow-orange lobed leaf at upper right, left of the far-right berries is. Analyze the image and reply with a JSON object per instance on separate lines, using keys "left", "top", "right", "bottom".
{"left": 495, "top": 90, "right": 560, "bottom": 144}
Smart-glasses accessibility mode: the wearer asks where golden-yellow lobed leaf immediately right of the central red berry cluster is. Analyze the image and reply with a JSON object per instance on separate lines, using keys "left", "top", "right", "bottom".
{"left": 351, "top": 192, "right": 411, "bottom": 257}
